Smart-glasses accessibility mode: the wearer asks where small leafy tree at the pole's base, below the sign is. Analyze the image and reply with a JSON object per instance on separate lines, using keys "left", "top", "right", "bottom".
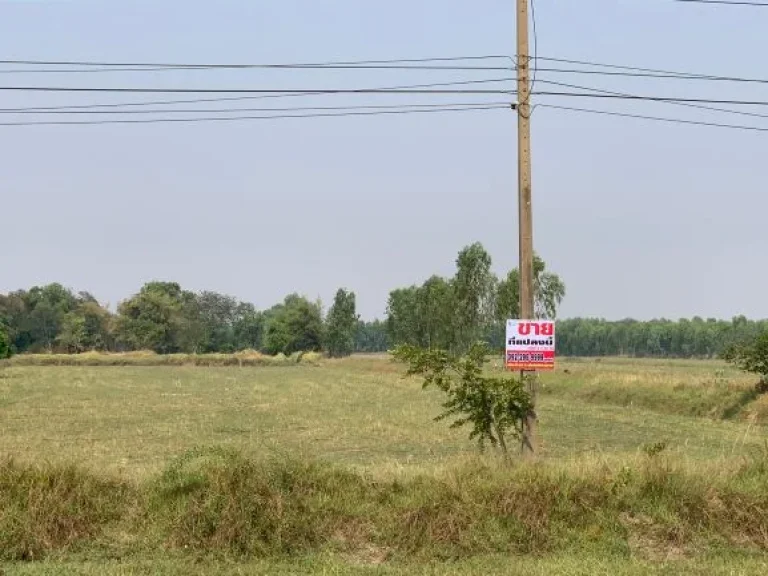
{"left": 394, "top": 344, "right": 532, "bottom": 457}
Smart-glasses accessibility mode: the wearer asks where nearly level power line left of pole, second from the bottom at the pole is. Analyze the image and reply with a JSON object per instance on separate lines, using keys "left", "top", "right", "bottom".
{"left": 0, "top": 102, "right": 513, "bottom": 115}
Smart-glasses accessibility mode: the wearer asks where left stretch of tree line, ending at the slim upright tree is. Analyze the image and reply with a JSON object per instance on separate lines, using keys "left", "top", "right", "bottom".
{"left": 0, "top": 282, "right": 360, "bottom": 356}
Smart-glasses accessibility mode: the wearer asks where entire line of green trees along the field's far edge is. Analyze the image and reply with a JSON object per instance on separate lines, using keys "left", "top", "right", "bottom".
{"left": 0, "top": 243, "right": 768, "bottom": 358}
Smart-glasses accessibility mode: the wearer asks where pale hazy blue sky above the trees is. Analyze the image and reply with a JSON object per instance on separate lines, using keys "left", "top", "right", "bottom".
{"left": 0, "top": 0, "right": 768, "bottom": 319}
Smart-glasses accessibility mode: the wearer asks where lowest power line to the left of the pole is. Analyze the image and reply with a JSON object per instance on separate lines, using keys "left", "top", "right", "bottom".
{"left": 0, "top": 104, "right": 510, "bottom": 127}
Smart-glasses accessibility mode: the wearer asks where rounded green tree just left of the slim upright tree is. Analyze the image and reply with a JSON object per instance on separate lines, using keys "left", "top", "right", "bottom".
{"left": 263, "top": 294, "right": 323, "bottom": 354}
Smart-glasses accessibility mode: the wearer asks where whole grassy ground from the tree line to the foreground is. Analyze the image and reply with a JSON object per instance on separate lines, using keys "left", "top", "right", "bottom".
{"left": 0, "top": 357, "right": 768, "bottom": 575}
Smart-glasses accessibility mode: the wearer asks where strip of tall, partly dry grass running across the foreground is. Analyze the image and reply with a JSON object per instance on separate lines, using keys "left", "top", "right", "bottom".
{"left": 0, "top": 445, "right": 768, "bottom": 562}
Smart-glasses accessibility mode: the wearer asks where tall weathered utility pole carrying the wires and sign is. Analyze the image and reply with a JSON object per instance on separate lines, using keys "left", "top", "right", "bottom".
{"left": 517, "top": 0, "right": 538, "bottom": 454}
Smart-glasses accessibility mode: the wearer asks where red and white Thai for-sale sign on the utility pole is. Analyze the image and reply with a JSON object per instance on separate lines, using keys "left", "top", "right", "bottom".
{"left": 506, "top": 320, "right": 555, "bottom": 371}
